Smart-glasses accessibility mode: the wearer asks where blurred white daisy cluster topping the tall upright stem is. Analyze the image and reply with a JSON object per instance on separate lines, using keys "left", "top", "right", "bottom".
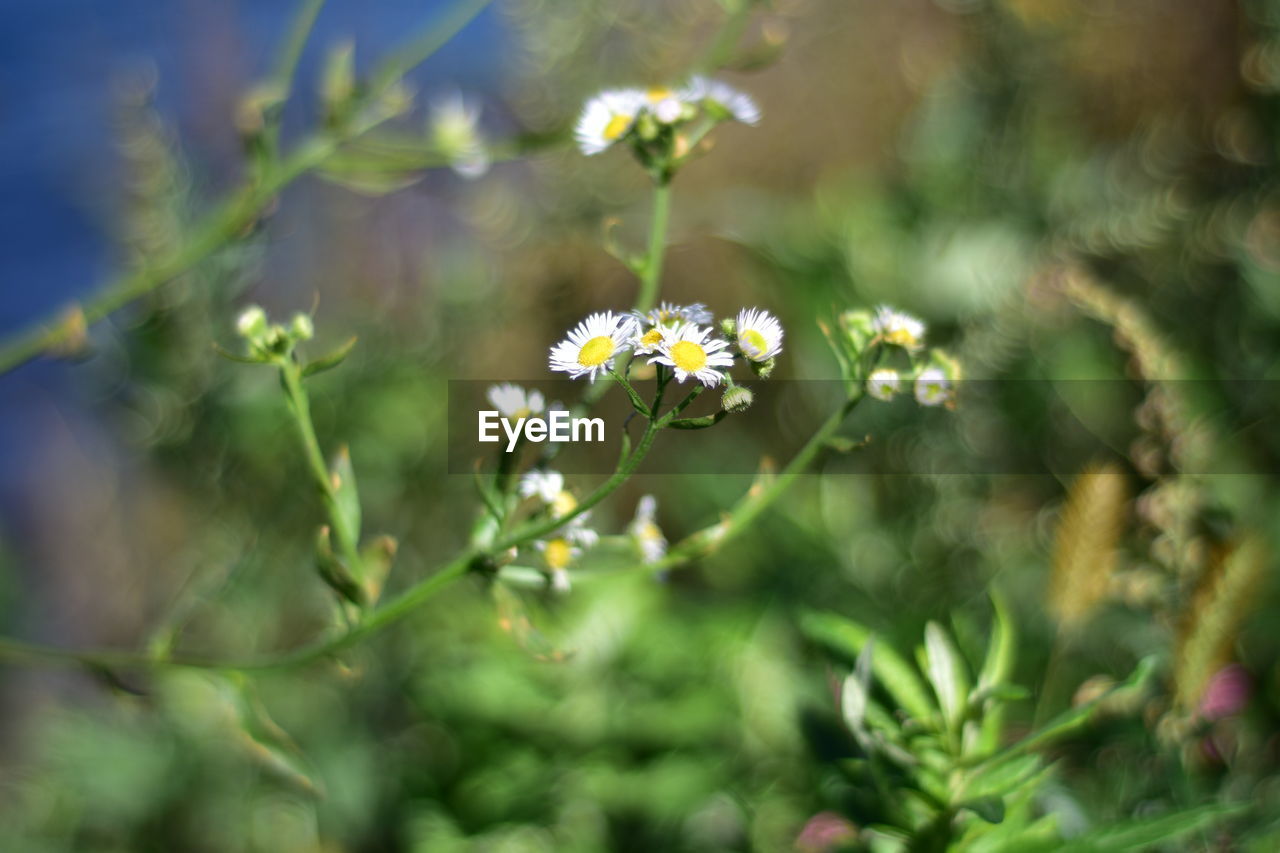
{"left": 573, "top": 76, "right": 760, "bottom": 175}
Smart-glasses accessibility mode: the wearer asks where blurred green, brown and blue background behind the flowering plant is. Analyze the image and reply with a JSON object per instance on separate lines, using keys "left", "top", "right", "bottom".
{"left": 0, "top": 0, "right": 1280, "bottom": 850}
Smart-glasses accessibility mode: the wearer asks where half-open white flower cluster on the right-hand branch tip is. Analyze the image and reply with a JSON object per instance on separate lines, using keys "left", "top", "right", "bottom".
{"left": 840, "top": 305, "right": 961, "bottom": 409}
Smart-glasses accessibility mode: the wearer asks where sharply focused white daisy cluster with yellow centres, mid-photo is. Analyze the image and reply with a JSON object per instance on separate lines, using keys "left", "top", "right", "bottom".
{"left": 550, "top": 302, "right": 783, "bottom": 388}
